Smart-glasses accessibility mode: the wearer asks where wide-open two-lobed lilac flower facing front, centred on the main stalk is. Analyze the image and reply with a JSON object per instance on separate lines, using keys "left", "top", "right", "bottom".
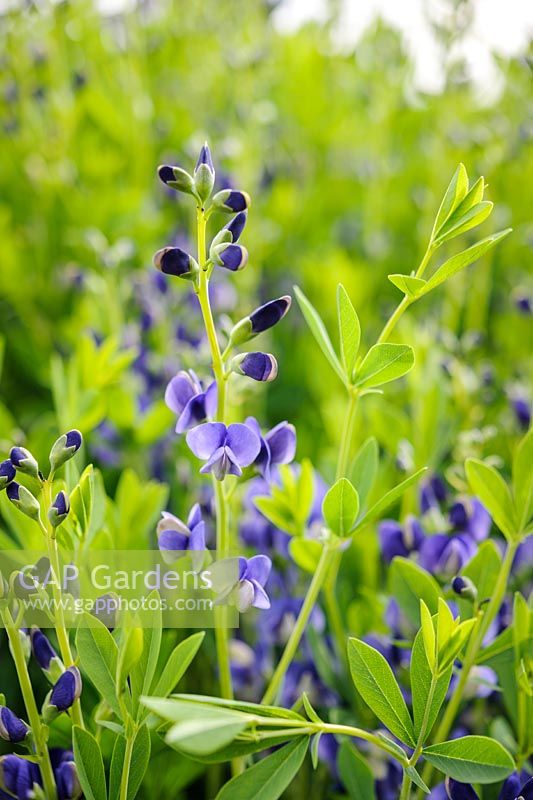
{"left": 187, "top": 422, "right": 261, "bottom": 481}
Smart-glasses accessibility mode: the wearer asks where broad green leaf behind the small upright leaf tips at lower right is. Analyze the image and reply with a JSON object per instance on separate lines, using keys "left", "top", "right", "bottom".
{"left": 389, "top": 556, "right": 442, "bottom": 628}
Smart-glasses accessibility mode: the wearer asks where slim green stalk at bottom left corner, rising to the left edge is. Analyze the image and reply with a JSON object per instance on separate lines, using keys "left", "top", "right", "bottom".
{"left": 0, "top": 608, "right": 57, "bottom": 800}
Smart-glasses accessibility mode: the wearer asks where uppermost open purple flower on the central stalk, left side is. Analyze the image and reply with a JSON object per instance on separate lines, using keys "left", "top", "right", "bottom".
{"left": 165, "top": 370, "right": 217, "bottom": 433}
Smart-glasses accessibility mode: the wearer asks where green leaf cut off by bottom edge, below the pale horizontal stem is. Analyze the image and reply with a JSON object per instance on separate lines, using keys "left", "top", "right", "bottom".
{"left": 216, "top": 736, "right": 309, "bottom": 800}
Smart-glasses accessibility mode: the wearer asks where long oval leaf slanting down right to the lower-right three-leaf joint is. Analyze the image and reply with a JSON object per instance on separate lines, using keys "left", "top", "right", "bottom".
{"left": 348, "top": 639, "right": 415, "bottom": 746}
